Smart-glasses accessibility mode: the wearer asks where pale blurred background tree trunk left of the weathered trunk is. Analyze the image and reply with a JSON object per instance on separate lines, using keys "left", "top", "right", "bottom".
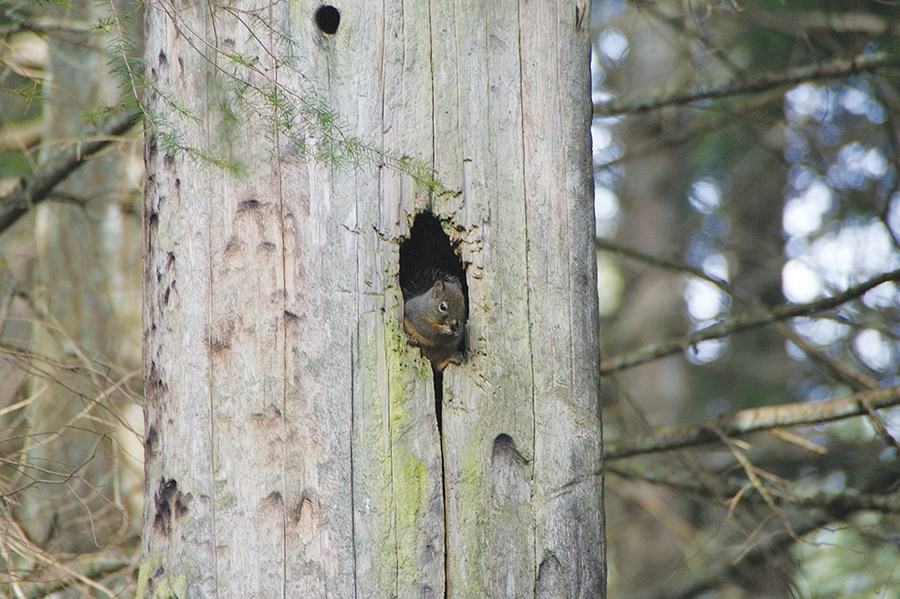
{"left": 22, "top": 0, "right": 141, "bottom": 552}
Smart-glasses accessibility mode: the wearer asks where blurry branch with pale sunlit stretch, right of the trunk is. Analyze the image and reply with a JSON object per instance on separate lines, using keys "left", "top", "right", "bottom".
{"left": 604, "top": 386, "right": 900, "bottom": 460}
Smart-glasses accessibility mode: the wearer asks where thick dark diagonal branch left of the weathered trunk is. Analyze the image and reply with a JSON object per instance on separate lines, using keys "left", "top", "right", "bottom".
{"left": 0, "top": 111, "right": 140, "bottom": 233}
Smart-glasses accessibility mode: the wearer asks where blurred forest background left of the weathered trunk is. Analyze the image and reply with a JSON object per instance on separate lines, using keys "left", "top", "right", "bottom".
{"left": 0, "top": 0, "right": 143, "bottom": 597}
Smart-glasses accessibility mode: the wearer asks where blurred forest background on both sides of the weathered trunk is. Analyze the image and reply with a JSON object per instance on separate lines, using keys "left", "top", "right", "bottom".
{"left": 0, "top": 0, "right": 900, "bottom": 597}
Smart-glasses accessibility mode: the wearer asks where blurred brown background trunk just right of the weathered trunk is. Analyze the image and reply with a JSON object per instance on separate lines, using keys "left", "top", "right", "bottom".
{"left": 603, "top": 19, "right": 690, "bottom": 596}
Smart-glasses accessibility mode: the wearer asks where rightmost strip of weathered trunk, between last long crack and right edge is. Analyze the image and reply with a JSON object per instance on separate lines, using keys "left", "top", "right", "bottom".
{"left": 519, "top": 2, "right": 605, "bottom": 597}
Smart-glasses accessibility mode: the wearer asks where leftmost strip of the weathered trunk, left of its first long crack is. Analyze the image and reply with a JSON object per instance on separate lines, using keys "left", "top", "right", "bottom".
{"left": 138, "top": 0, "right": 217, "bottom": 597}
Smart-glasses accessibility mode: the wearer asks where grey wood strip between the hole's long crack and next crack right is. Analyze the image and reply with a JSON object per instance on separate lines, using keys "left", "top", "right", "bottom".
{"left": 432, "top": 1, "right": 540, "bottom": 597}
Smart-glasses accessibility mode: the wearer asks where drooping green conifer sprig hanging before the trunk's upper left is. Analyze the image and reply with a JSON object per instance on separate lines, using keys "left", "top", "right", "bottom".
{"left": 125, "top": 1, "right": 448, "bottom": 195}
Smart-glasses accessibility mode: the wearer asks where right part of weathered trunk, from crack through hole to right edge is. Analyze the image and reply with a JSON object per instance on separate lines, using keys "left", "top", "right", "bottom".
{"left": 432, "top": 2, "right": 604, "bottom": 597}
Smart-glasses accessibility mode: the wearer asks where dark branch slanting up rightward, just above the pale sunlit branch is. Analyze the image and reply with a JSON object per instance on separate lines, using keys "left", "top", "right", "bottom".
{"left": 600, "top": 269, "right": 900, "bottom": 375}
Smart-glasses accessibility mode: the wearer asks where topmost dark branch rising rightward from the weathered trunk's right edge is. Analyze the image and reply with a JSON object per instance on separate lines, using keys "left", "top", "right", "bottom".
{"left": 594, "top": 52, "right": 898, "bottom": 117}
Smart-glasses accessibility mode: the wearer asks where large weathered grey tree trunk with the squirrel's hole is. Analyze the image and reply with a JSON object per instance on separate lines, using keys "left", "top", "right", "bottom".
{"left": 139, "top": 1, "right": 605, "bottom": 597}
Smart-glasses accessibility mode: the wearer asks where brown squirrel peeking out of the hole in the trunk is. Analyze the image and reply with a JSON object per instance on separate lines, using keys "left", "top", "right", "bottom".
{"left": 403, "top": 270, "right": 466, "bottom": 372}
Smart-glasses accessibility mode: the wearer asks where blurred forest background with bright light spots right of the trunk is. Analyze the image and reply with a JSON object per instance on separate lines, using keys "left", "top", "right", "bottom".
{"left": 592, "top": 0, "right": 900, "bottom": 597}
